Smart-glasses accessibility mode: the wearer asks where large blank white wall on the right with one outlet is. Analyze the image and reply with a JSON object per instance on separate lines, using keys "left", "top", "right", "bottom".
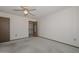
{"left": 38, "top": 7, "right": 79, "bottom": 47}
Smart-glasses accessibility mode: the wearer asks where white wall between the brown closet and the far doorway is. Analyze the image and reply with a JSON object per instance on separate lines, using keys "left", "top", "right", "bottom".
{"left": 0, "top": 12, "right": 28, "bottom": 40}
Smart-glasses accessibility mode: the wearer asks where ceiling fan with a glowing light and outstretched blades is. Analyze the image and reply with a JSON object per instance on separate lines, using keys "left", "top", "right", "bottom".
{"left": 14, "top": 6, "right": 36, "bottom": 17}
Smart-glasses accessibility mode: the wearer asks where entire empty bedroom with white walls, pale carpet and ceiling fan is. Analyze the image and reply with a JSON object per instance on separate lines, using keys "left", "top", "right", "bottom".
{"left": 0, "top": 6, "right": 79, "bottom": 53}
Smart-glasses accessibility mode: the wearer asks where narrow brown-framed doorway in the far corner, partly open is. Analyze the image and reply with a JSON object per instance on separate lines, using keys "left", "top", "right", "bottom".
{"left": 29, "top": 21, "right": 38, "bottom": 37}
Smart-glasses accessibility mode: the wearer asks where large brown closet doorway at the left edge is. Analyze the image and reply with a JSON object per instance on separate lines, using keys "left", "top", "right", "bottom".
{"left": 0, "top": 17, "right": 10, "bottom": 43}
